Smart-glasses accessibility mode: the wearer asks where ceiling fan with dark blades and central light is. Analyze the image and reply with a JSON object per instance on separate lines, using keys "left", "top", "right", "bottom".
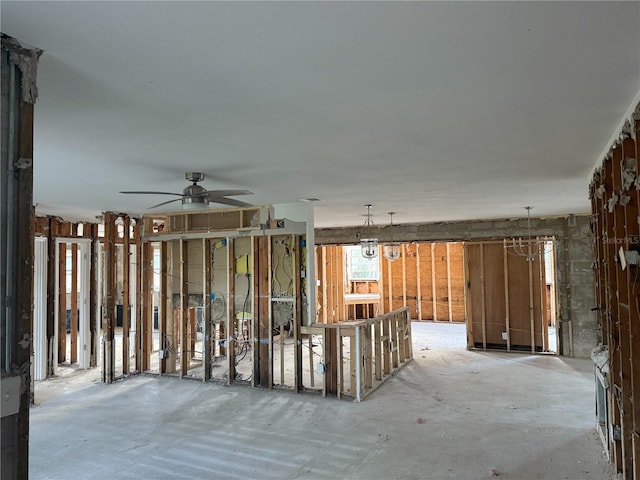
{"left": 120, "top": 172, "right": 253, "bottom": 210}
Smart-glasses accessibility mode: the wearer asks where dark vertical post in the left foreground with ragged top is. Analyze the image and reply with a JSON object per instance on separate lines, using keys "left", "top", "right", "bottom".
{"left": 0, "top": 38, "right": 42, "bottom": 479}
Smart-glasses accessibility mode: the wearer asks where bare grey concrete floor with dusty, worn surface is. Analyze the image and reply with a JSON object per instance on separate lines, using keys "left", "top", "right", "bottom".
{"left": 30, "top": 323, "right": 615, "bottom": 480}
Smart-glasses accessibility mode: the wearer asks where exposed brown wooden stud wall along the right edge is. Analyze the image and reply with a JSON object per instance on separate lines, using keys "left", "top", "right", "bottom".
{"left": 590, "top": 105, "right": 640, "bottom": 479}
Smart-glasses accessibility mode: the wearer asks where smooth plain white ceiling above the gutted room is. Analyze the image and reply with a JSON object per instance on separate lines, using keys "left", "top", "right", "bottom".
{"left": 0, "top": 0, "right": 640, "bottom": 227}
